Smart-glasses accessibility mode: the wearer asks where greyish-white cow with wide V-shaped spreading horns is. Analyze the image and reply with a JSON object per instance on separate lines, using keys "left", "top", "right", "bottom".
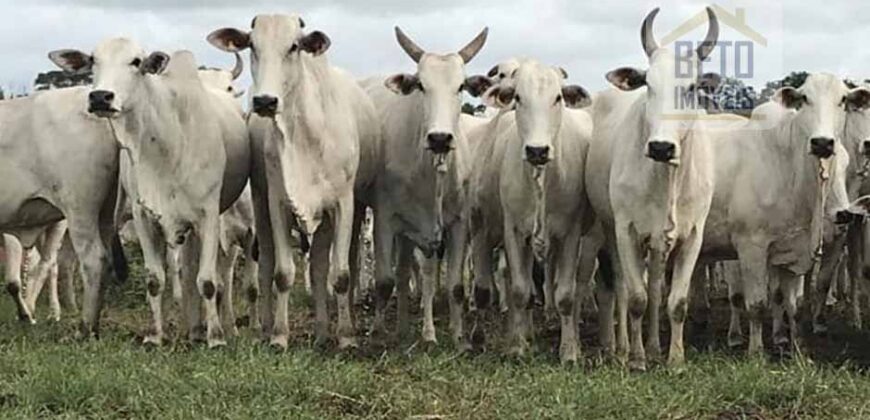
{"left": 363, "top": 28, "right": 489, "bottom": 349}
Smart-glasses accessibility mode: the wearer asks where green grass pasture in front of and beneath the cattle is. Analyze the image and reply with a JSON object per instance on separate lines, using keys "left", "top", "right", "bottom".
{"left": 0, "top": 248, "right": 870, "bottom": 419}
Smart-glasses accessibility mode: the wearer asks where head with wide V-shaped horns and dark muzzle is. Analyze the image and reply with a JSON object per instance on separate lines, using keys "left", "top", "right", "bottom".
{"left": 384, "top": 27, "right": 491, "bottom": 155}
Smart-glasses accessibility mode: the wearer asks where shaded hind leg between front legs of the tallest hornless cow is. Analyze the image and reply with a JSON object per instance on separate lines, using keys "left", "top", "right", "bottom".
{"left": 308, "top": 219, "right": 334, "bottom": 345}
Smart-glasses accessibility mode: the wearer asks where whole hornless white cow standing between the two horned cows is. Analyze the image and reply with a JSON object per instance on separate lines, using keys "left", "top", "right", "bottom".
{"left": 472, "top": 60, "right": 592, "bottom": 362}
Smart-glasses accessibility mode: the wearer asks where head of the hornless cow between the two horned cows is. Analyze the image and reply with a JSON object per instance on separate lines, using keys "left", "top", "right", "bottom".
{"left": 484, "top": 61, "right": 592, "bottom": 167}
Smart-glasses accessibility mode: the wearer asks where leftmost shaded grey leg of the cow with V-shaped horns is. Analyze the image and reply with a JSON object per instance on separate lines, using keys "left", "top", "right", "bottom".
{"left": 372, "top": 209, "right": 396, "bottom": 335}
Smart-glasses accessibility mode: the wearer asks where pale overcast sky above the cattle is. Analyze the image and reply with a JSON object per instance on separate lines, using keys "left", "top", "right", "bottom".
{"left": 0, "top": 0, "right": 870, "bottom": 92}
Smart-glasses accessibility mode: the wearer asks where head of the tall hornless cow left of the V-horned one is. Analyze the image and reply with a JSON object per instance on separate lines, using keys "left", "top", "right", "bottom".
{"left": 208, "top": 15, "right": 331, "bottom": 118}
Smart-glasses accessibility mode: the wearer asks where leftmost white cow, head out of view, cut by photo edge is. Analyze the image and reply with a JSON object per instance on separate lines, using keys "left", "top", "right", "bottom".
{"left": 0, "top": 87, "right": 126, "bottom": 337}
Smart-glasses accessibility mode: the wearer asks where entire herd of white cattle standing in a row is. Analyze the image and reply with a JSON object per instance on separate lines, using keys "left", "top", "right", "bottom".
{"left": 0, "top": 9, "right": 870, "bottom": 369}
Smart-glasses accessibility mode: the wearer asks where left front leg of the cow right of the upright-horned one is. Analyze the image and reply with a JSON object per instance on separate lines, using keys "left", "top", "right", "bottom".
{"left": 736, "top": 240, "right": 769, "bottom": 356}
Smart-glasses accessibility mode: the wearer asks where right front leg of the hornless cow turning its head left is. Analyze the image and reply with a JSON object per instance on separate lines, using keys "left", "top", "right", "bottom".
{"left": 193, "top": 211, "right": 227, "bottom": 348}
